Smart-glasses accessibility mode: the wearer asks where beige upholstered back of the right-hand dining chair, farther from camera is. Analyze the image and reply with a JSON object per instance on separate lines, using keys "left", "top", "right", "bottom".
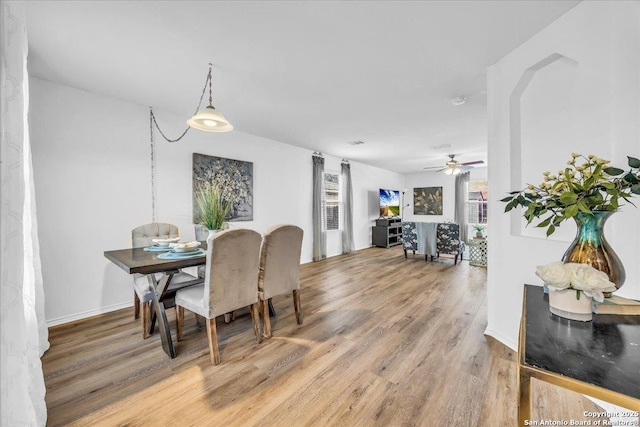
{"left": 258, "top": 225, "right": 304, "bottom": 300}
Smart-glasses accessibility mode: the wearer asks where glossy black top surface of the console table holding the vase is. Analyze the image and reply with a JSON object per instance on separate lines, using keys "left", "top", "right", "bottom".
{"left": 524, "top": 285, "right": 640, "bottom": 398}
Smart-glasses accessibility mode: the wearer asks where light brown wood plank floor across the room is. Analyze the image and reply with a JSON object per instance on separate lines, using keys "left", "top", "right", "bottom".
{"left": 42, "top": 247, "right": 598, "bottom": 427}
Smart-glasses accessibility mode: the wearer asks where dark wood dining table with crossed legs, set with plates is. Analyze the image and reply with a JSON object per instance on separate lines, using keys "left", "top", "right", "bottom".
{"left": 104, "top": 242, "right": 207, "bottom": 358}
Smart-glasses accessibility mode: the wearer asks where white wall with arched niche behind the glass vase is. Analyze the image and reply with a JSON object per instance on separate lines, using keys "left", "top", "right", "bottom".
{"left": 486, "top": 1, "right": 640, "bottom": 348}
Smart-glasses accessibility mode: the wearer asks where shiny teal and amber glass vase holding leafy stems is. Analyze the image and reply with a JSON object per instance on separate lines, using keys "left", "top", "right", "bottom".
{"left": 562, "top": 211, "right": 626, "bottom": 296}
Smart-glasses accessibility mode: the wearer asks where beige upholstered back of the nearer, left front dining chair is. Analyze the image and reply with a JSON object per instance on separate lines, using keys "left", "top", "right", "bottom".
{"left": 204, "top": 228, "right": 262, "bottom": 318}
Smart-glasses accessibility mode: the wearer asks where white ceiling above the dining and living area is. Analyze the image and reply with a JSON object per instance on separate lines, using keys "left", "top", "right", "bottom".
{"left": 26, "top": 0, "right": 578, "bottom": 173}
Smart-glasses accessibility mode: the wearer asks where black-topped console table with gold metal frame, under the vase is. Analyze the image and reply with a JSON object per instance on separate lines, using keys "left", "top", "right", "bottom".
{"left": 518, "top": 285, "right": 640, "bottom": 426}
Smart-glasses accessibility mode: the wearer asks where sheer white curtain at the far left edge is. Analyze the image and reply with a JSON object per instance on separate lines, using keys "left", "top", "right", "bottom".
{"left": 0, "top": 1, "right": 49, "bottom": 426}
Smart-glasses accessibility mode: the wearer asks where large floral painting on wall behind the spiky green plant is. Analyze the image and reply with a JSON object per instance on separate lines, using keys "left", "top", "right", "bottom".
{"left": 193, "top": 153, "right": 253, "bottom": 223}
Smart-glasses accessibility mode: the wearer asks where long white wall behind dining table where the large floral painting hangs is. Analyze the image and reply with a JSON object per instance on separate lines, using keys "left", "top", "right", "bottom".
{"left": 30, "top": 79, "right": 403, "bottom": 325}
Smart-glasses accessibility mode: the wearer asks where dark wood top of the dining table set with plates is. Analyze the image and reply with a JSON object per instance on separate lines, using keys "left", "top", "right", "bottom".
{"left": 104, "top": 244, "right": 207, "bottom": 274}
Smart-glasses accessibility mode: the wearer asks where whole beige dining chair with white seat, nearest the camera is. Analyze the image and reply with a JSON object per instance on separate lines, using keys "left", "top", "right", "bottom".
{"left": 175, "top": 229, "right": 262, "bottom": 365}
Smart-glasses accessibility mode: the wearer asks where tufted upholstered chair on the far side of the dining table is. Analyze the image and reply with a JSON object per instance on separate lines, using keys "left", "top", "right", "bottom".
{"left": 131, "top": 222, "right": 195, "bottom": 338}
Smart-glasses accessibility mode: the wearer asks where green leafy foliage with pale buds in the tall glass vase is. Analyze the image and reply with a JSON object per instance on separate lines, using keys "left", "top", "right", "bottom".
{"left": 500, "top": 153, "right": 640, "bottom": 237}
